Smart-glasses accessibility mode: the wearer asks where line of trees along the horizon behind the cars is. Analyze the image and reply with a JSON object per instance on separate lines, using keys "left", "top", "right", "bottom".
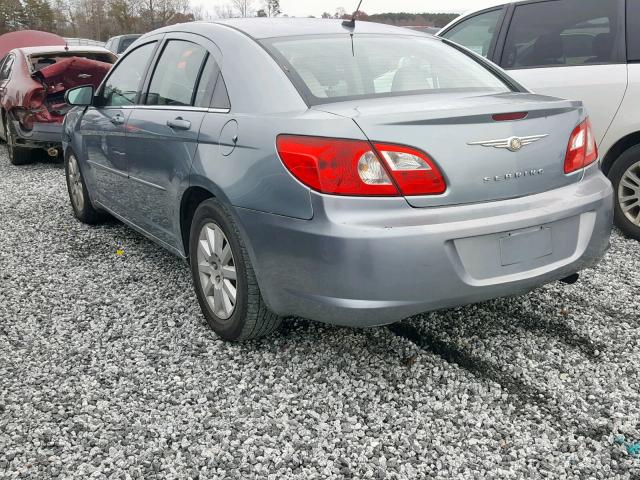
{"left": 0, "top": 0, "right": 456, "bottom": 41}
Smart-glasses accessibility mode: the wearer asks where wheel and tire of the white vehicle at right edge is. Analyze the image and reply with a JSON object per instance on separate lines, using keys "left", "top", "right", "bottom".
{"left": 609, "top": 145, "right": 640, "bottom": 240}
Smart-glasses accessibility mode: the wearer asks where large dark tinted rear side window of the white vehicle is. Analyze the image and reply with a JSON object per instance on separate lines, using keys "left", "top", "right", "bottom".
{"left": 501, "top": 0, "right": 624, "bottom": 68}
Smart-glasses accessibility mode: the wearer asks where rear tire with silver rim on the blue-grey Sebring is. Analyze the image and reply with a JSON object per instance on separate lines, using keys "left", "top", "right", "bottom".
{"left": 189, "top": 199, "right": 282, "bottom": 341}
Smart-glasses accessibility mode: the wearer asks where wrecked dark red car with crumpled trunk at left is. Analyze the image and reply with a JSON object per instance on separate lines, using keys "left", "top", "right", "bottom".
{"left": 0, "top": 31, "right": 117, "bottom": 165}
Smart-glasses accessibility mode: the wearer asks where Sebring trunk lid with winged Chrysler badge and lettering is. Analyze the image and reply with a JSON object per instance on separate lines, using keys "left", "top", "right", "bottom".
{"left": 313, "top": 93, "right": 584, "bottom": 207}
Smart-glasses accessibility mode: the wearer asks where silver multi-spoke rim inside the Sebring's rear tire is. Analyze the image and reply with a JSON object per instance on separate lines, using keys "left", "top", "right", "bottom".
{"left": 197, "top": 223, "right": 238, "bottom": 320}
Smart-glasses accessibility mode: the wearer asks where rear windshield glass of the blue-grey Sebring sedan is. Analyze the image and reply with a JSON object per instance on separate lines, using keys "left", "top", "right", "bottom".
{"left": 263, "top": 35, "right": 510, "bottom": 105}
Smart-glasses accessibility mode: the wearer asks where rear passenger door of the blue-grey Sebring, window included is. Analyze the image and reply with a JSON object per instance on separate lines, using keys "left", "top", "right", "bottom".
{"left": 126, "top": 34, "right": 219, "bottom": 247}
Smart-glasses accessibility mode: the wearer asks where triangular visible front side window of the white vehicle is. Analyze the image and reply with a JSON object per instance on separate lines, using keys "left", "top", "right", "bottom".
{"left": 442, "top": 9, "right": 502, "bottom": 57}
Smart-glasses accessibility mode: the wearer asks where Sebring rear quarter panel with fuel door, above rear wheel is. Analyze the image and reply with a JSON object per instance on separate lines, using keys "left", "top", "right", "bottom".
{"left": 191, "top": 111, "right": 365, "bottom": 219}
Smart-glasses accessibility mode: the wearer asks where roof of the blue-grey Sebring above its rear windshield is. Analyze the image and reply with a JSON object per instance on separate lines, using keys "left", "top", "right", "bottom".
{"left": 202, "top": 18, "right": 428, "bottom": 39}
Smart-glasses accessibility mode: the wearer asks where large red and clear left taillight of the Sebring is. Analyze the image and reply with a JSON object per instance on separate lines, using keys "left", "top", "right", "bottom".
{"left": 277, "top": 135, "right": 446, "bottom": 197}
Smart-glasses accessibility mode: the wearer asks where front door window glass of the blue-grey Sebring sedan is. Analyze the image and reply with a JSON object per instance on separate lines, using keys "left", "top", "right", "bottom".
{"left": 101, "top": 42, "right": 156, "bottom": 107}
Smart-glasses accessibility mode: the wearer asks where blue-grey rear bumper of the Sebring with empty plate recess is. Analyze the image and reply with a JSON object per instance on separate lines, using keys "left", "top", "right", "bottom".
{"left": 236, "top": 169, "right": 613, "bottom": 326}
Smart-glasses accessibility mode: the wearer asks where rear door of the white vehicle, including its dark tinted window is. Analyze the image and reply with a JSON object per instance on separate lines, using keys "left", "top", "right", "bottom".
{"left": 496, "top": 0, "right": 627, "bottom": 144}
